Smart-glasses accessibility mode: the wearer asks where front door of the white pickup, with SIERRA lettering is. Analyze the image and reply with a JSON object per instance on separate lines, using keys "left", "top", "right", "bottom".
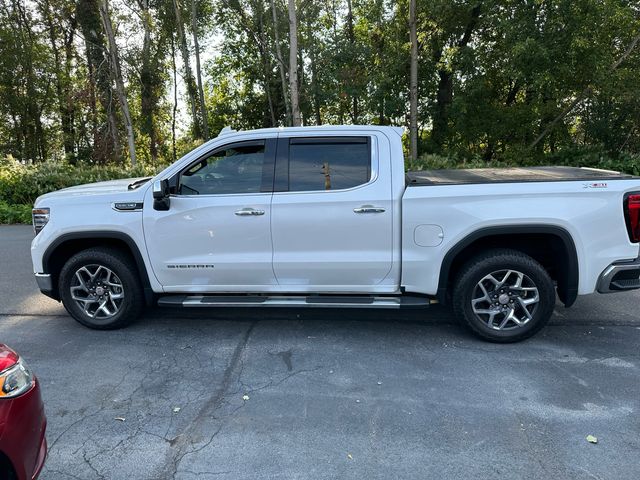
{"left": 144, "top": 139, "right": 276, "bottom": 292}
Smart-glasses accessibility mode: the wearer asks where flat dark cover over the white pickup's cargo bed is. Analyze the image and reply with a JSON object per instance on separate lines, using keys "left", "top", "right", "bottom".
{"left": 406, "top": 167, "right": 635, "bottom": 186}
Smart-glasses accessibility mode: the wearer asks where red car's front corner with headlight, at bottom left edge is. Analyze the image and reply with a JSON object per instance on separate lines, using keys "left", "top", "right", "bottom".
{"left": 0, "top": 343, "right": 47, "bottom": 480}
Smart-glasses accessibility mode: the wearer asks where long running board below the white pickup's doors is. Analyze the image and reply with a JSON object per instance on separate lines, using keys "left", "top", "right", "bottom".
{"left": 158, "top": 295, "right": 436, "bottom": 308}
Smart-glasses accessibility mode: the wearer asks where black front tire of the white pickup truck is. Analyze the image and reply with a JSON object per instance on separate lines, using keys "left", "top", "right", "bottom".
{"left": 59, "top": 247, "right": 144, "bottom": 330}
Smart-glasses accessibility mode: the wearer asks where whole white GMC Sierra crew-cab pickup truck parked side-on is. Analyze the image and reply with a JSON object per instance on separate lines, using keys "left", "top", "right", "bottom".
{"left": 31, "top": 126, "right": 640, "bottom": 342}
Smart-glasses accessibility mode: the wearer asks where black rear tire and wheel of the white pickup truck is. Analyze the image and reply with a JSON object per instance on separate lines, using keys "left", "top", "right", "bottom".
{"left": 452, "top": 249, "right": 556, "bottom": 343}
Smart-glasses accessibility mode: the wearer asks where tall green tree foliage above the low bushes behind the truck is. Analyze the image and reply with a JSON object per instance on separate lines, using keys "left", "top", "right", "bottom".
{"left": 0, "top": 0, "right": 640, "bottom": 170}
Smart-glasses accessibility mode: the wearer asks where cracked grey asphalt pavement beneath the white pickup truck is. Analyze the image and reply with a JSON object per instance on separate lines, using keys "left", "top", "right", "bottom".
{"left": 0, "top": 226, "right": 640, "bottom": 480}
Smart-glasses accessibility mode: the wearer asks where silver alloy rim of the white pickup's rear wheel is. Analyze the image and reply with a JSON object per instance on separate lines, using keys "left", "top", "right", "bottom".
{"left": 471, "top": 270, "right": 540, "bottom": 330}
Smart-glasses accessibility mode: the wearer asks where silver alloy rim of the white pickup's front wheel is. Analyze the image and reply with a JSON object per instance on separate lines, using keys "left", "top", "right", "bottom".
{"left": 70, "top": 265, "right": 124, "bottom": 319}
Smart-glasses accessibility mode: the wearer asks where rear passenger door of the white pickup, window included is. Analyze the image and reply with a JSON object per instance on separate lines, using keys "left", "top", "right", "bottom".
{"left": 271, "top": 134, "right": 393, "bottom": 292}
